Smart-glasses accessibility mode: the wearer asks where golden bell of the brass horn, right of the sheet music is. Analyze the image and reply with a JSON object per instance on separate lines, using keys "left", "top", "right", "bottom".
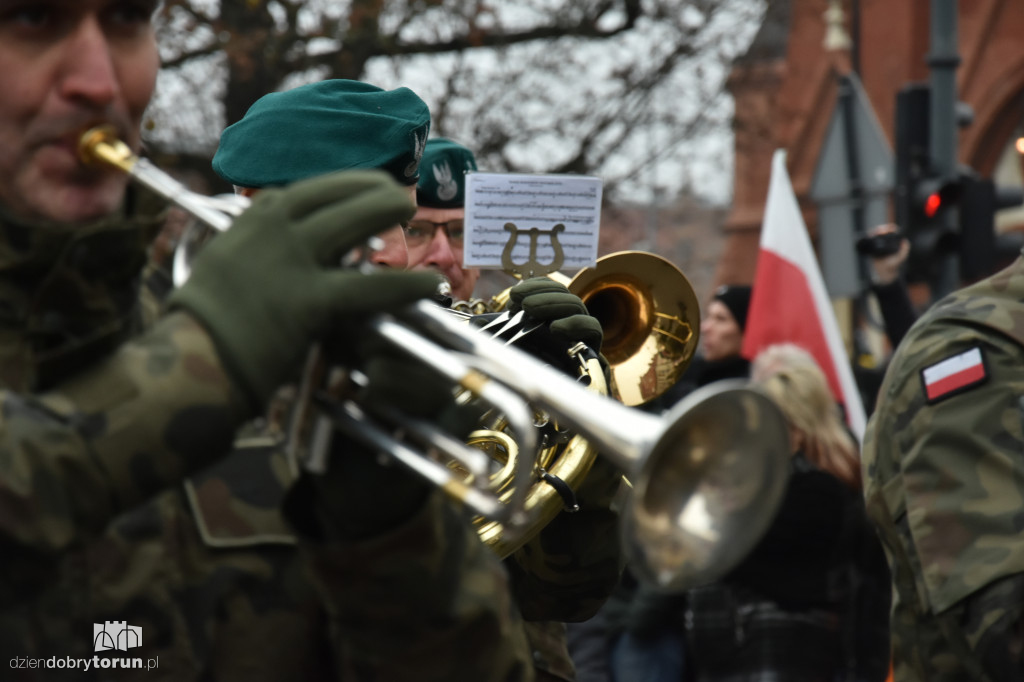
{"left": 567, "top": 251, "right": 700, "bottom": 407}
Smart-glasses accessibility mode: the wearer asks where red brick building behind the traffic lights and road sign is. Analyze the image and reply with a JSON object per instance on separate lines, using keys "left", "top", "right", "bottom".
{"left": 715, "top": 0, "right": 1024, "bottom": 282}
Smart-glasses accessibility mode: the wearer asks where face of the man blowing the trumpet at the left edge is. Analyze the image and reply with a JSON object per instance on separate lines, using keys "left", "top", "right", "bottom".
{"left": 0, "top": 0, "right": 160, "bottom": 222}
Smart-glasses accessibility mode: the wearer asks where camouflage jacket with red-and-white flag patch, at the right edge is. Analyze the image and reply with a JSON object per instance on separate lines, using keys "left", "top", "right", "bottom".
{"left": 863, "top": 251, "right": 1024, "bottom": 682}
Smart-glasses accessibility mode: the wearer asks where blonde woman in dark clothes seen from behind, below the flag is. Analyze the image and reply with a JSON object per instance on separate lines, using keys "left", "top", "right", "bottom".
{"left": 687, "top": 344, "right": 889, "bottom": 682}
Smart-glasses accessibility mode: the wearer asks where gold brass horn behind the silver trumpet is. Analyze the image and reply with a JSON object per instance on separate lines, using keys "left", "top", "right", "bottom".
{"left": 454, "top": 246, "right": 700, "bottom": 557}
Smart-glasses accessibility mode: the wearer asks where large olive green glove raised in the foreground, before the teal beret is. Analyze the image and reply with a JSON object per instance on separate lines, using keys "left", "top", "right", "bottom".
{"left": 169, "top": 171, "right": 437, "bottom": 409}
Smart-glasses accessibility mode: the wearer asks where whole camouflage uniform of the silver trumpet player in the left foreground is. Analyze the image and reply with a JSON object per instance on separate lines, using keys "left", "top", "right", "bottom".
{"left": 0, "top": 189, "right": 552, "bottom": 681}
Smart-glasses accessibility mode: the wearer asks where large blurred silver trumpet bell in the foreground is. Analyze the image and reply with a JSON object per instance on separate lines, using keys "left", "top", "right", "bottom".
{"left": 622, "top": 381, "right": 790, "bottom": 592}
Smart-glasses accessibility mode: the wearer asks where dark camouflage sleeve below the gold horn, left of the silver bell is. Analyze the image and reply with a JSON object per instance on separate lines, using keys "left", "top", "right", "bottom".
{"left": 506, "top": 456, "right": 623, "bottom": 623}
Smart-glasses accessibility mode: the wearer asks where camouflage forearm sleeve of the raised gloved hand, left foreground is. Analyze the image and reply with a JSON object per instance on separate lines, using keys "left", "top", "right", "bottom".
{"left": 0, "top": 314, "right": 245, "bottom": 561}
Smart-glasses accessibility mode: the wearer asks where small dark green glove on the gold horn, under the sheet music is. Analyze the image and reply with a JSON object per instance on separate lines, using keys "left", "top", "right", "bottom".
{"left": 508, "top": 278, "right": 603, "bottom": 352}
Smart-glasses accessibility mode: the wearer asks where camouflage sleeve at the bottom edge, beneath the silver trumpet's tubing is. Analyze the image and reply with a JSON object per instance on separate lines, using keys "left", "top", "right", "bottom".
{"left": 286, "top": 479, "right": 534, "bottom": 682}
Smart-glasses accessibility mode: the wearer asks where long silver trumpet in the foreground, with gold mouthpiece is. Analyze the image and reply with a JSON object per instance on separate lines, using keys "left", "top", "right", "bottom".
{"left": 80, "top": 125, "right": 790, "bottom": 590}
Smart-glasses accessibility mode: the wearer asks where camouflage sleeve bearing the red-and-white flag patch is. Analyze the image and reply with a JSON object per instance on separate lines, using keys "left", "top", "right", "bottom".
{"left": 879, "top": 324, "right": 1024, "bottom": 612}
